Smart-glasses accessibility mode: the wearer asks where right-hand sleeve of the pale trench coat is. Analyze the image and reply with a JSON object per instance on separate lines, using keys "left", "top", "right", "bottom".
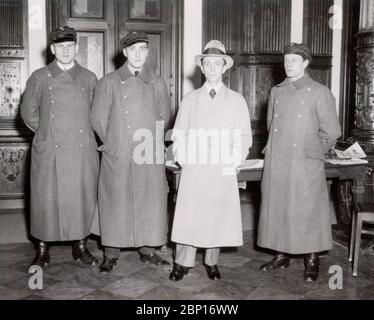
{"left": 234, "top": 97, "right": 252, "bottom": 161}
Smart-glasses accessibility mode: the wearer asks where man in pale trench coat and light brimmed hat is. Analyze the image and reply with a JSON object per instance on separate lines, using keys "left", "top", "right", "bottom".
{"left": 169, "top": 40, "right": 252, "bottom": 281}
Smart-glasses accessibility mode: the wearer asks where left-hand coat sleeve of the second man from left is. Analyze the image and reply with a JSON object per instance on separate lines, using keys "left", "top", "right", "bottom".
{"left": 90, "top": 78, "right": 113, "bottom": 142}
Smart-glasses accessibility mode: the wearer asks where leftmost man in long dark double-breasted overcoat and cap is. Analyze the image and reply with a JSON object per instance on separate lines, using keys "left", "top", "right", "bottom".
{"left": 21, "top": 26, "right": 99, "bottom": 267}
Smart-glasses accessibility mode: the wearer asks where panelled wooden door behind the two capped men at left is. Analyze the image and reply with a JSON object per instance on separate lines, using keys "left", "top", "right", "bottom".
{"left": 47, "top": 0, "right": 183, "bottom": 111}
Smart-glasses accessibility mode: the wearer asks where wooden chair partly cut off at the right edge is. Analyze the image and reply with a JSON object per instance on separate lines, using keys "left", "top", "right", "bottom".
{"left": 349, "top": 203, "right": 374, "bottom": 277}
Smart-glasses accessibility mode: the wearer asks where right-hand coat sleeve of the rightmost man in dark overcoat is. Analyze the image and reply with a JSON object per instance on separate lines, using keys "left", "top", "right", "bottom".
{"left": 317, "top": 88, "right": 341, "bottom": 153}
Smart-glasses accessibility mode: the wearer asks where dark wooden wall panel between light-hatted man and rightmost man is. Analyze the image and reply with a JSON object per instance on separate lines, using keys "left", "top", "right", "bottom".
{"left": 203, "top": 0, "right": 291, "bottom": 158}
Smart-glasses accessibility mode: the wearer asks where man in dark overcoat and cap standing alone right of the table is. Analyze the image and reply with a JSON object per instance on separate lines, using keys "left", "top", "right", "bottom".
{"left": 257, "top": 43, "right": 341, "bottom": 281}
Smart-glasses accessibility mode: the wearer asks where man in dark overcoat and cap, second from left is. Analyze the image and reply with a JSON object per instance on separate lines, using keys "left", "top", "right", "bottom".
{"left": 91, "top": 31, "right": 171, "bottom": 273}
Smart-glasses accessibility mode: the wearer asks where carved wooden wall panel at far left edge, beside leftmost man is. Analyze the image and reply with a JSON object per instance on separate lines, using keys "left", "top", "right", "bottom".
{"left": 0, "top": 0, "right": 31, "bottom": 214}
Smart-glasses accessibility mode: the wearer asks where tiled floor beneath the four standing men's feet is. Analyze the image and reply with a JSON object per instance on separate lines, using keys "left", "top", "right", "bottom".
{"left": 0, "top": 231, "right": 374, "bottom": 300}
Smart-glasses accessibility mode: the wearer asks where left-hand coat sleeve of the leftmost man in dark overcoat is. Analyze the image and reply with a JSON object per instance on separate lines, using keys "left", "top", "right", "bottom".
{"left": 20, "top": 74, "right": 42, "bottom": 132}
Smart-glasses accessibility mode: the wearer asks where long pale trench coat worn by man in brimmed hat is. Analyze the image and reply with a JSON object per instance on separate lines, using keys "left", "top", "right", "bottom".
{"left": 171, "top": 85, "right": 252, "bottom": 248}
